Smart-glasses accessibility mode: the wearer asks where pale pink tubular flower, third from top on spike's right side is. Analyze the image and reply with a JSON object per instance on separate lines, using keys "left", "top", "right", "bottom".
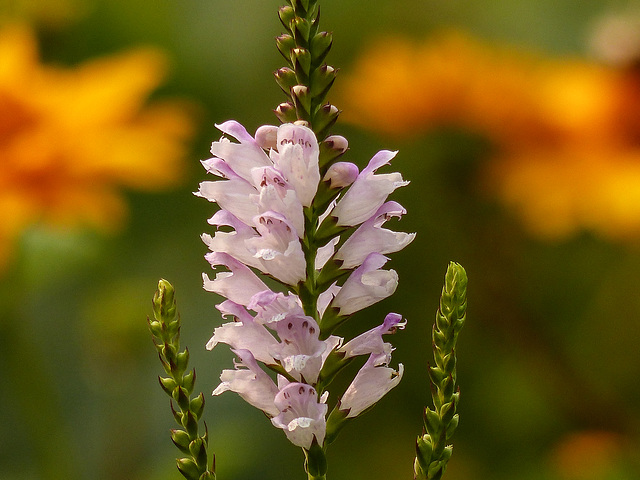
{"left": 331, "top": 253, "right": 398, "bottom": 315}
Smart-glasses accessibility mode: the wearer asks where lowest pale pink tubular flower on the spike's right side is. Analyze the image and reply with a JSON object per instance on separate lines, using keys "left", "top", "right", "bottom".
{"left": 339, "top": 353, "right": 404, "bottom": 418}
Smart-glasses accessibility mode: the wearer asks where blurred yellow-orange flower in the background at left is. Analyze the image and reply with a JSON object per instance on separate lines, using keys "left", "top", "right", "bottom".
{"left": 0, "top": 26, "right": 192, "bottom": 271}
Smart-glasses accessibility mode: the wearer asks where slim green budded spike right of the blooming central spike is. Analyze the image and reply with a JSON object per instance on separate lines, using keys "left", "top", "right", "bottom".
{"left": 414, "top": 262, "right": 467, "bottom": 480}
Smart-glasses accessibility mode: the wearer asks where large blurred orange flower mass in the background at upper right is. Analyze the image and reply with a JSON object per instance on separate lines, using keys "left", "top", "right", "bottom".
{"left": 340, "top": 33, "right": 640, "bottom": 239}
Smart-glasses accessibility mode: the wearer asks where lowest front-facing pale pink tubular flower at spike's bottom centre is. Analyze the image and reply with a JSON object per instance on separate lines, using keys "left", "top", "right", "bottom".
{"left": 271, "top": 382, "right": 327, "bottom": 450}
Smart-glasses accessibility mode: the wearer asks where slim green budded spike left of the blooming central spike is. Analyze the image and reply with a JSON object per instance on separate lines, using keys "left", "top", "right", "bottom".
{"left": 147, "top": 280, "right": 216, "bottom": 480}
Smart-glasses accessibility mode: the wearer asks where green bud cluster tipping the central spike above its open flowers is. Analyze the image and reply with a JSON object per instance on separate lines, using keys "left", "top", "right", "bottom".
{"left": 274, "top": 0, "right": 340, "bottom": 138}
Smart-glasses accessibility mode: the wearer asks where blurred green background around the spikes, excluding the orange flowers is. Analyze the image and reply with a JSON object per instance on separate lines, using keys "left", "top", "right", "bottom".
{"left": 0, "top": 0, "right": 640, "bottom": 480}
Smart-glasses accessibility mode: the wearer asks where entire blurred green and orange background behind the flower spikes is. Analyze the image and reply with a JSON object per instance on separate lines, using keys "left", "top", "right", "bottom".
{"left": 0, "top": 0, "right": 640, "bottom": 480}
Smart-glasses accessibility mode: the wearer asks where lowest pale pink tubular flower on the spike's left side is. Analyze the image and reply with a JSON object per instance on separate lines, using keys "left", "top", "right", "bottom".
{"left": 213, "top": 350, "right": 280, "bottom": 416}
